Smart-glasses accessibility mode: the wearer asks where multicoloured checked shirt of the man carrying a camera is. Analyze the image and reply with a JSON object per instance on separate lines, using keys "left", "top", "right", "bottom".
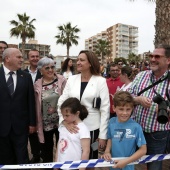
{"left": 128, "top": 70, "right": 170, "bottom": 133}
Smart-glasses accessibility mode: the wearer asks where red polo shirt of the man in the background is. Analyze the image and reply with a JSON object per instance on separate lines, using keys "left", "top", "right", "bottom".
{"left": 106, "top": 77, "right": 124, "bottom": 113}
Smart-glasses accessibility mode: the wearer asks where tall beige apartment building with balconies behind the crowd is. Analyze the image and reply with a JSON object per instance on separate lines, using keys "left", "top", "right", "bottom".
{"left": 85, "top": 23, "right": 138, "bottom": 63}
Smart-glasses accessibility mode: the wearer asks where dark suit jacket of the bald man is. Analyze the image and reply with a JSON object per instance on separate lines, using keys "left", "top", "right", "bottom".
{"left": 0, "top": 66, "right": 36, "bottom": 137}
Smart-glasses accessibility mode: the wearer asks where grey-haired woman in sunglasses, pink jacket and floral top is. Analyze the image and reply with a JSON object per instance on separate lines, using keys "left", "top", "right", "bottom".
{"left": 34, "top": 57, "right": 66, "bottom": 162}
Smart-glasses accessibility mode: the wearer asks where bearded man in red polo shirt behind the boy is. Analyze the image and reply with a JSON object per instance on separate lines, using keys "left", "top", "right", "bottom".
{"left": 106, "top": 64, "right": 123, "bottom": 118}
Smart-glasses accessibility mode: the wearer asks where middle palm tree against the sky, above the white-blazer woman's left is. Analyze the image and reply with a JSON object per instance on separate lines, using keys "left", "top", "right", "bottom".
{"left": 55, "top": 22, "right": 80, "bottom": 57}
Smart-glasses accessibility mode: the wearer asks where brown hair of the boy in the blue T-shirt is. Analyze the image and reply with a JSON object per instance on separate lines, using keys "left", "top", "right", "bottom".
{"left": 113, "top": 91, "right": 135, "bottom": 107}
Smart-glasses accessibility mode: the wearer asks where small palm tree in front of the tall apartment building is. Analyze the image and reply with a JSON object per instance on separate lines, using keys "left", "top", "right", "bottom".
{"left": 95, "top": 39, "right": 111, "bottom": 63}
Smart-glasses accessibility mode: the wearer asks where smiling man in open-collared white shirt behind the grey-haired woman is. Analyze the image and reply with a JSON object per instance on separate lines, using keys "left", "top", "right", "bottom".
{"left": 24, "top": 49, "right": 42, "bottom": 163}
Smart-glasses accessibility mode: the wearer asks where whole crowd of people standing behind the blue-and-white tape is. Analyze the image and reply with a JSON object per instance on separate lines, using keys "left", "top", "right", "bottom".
{"left": 0, "top": 41, "right": 170, "bottom": 170}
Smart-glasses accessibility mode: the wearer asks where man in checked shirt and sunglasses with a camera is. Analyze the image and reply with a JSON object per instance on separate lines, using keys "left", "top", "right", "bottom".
{"left": 129, "top": 45, "right": 170, "bottom": 170}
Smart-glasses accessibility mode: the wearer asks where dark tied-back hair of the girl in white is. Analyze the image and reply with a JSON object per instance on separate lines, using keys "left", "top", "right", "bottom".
{"left": 61, "top": 97, "right": 88, "bottom": 120}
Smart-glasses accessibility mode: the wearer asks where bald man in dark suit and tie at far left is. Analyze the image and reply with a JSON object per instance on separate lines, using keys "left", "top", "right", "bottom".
{"left": 0, "top": 48, "right": 36, "bottom": 165}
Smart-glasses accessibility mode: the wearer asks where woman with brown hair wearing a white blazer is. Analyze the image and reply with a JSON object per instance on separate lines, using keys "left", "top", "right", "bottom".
{"left": 58, "top": 50, "right": 110, "bottom": 159}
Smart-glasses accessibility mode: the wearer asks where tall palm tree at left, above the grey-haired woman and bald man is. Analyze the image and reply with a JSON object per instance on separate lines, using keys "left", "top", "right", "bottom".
{"left": 10, "top": 13, "right": 36, "bottom": 57}
